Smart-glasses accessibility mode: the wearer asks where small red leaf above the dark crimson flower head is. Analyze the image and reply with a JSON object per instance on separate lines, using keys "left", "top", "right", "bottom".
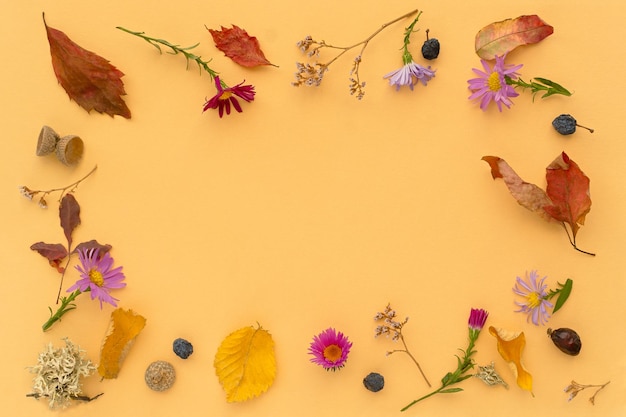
{"left": 207, "top": 25, "right": 274, "bottom": 67}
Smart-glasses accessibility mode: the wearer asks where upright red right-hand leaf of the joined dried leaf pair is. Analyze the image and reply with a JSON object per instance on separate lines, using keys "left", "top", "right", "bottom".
{"left": 544, "top": 152, "right": 591, "bottom": 239}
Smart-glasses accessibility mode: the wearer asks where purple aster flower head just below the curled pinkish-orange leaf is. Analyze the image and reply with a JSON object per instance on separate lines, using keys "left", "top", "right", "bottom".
{"left": 467, "top": 54, "right": 522, "bottom": 111}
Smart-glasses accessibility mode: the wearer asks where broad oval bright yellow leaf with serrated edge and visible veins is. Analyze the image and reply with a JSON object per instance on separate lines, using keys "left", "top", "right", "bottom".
{"left": 213, "top": 326, "right": 276, "bottom": 402}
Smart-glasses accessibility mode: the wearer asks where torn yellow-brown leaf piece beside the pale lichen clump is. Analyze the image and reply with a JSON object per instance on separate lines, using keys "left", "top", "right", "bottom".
{"left": 98, "top": 308, "right": 146, "bottom": 379}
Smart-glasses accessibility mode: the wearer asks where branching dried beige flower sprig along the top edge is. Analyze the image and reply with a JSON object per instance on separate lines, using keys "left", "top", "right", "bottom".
{"left": 291, "top": 9, "right": 418, "bottom": 100}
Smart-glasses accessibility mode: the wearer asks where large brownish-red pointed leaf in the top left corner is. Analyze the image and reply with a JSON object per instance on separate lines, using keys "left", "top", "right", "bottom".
{"left": 43, "top": 17, "right": 130, "bottom": 119}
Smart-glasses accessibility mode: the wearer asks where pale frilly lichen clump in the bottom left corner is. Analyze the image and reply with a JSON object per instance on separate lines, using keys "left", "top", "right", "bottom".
{"left": 27, "top": 338, "right": 102, "bottom": 409}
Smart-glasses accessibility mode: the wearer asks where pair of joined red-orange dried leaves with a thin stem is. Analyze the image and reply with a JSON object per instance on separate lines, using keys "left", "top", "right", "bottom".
{"left": 482, "top": 152, "right": 593, "bottom": 255}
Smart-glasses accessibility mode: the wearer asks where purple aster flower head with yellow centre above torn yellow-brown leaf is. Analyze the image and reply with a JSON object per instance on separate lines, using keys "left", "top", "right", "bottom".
{"left": 67, "top": 248, "right": 126, "bottom": 308}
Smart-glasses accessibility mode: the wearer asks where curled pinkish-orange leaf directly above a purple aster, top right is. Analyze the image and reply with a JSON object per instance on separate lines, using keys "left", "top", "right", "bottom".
{"left": 475, "top": 15, "right": 554, "bottom": 61}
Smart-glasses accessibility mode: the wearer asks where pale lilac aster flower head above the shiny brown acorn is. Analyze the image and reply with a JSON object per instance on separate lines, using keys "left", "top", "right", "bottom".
{"left": 513, "top": 271, "right": 554, "bottom": 326}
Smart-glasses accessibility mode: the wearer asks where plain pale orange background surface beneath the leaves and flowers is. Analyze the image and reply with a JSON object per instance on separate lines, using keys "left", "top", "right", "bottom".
{"left": 0, "top": 0, "right": 626, "bottom": 417}
